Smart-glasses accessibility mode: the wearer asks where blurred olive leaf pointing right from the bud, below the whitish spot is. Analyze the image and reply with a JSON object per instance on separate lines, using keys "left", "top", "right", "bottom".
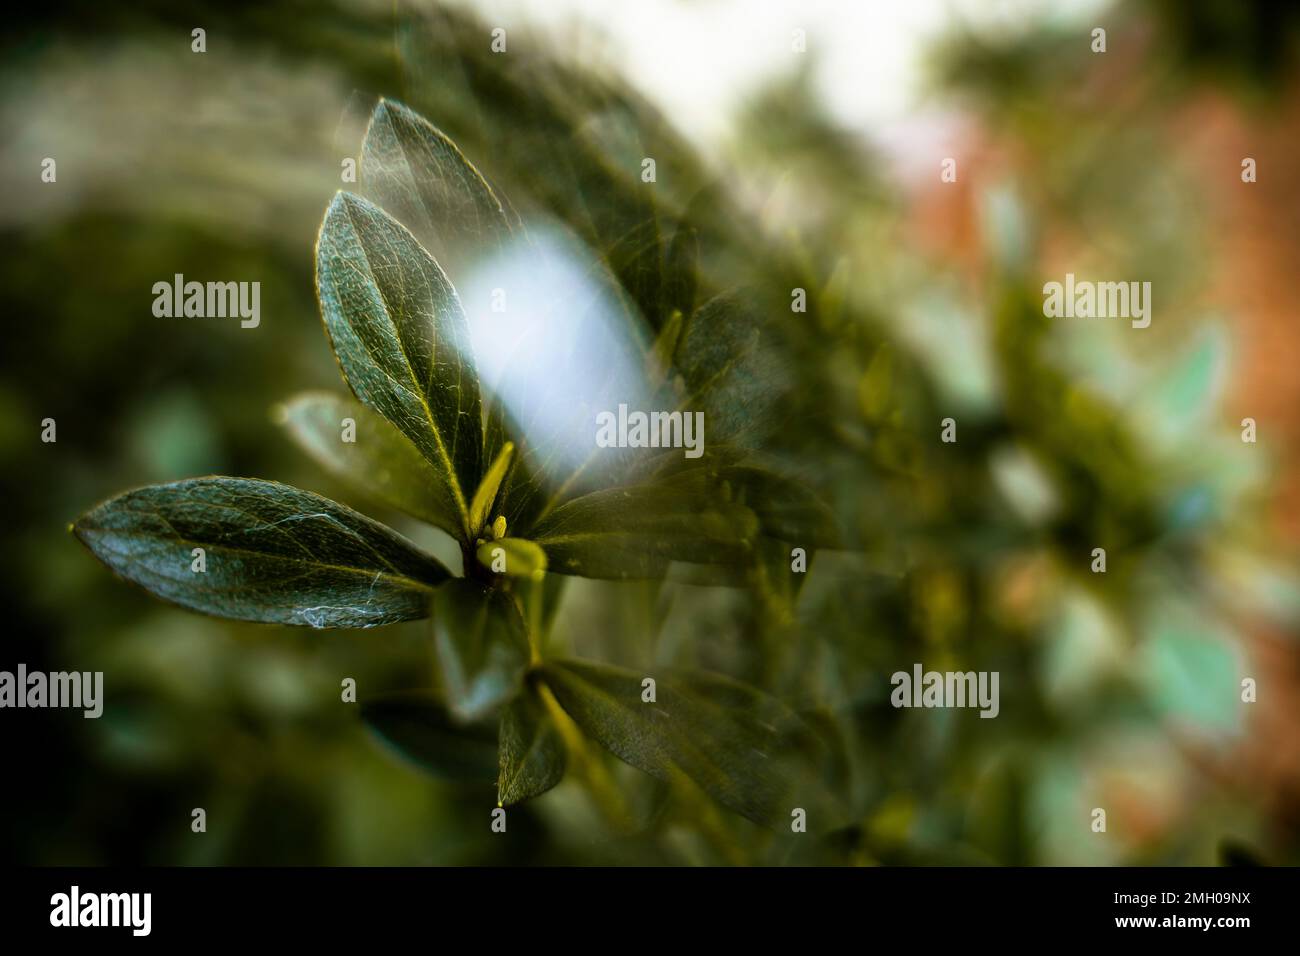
{"left": 533, "top": 475, "right": 758, "bottom": 579}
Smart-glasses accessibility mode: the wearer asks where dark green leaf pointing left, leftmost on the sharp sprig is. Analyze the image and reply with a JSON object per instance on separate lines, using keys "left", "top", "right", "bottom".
{"left": 73, "top": 477, "right": 449, "bottom": 627}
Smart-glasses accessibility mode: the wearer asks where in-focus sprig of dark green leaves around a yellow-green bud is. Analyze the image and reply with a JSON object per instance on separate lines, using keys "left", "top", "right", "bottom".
{"left": 74, "top": 100, "right": 835, "bottom": 823}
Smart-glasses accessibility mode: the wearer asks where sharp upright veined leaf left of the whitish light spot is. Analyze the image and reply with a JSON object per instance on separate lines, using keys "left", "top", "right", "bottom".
{"left": 316, "top": 193, "right": 482, "bottom": 537}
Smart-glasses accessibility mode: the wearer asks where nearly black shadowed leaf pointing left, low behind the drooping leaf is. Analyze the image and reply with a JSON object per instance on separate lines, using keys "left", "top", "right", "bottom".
{"left": 361, "top": 691, "right": 497, "bottom": 783}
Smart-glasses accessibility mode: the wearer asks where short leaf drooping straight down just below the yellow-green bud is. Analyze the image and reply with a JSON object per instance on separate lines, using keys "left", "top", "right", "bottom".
{"left": 432, "top": 579, "right": 528, "bottom": 721}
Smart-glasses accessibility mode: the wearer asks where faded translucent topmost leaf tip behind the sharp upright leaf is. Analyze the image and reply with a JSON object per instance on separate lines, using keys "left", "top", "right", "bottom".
{"left": 361, "top": 99, "right": 511, "bottom": 282}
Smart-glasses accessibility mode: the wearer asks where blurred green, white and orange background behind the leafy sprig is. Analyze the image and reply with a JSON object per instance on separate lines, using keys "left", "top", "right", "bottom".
{"left": 0, "top": 0, "right": 1300, "bottom": 865}
